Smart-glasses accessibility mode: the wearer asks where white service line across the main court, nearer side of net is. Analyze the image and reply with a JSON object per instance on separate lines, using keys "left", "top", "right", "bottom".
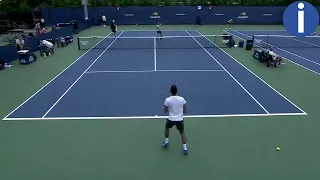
{"left": 86, "top": 69, "right": 225, "bottom": 74}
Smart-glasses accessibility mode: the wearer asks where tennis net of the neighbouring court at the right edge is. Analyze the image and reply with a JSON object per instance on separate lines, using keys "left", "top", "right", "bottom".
{"left": 253, "top": 35, "right": 320, "bottom": 48}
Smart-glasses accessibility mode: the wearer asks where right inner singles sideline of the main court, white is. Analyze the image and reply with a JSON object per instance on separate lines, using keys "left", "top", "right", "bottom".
{"left": 186, "top": 30, "right": 270, "bottom": 114}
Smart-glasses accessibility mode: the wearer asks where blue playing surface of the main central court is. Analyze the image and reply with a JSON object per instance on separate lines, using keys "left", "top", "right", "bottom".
{"left": 3, "top": 30, "right": 306, "bottom": 120}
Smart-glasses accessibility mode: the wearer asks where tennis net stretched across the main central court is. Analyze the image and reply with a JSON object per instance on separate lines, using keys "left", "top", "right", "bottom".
{"left": 78, "top": 35, "right": 232, "bottom": 50}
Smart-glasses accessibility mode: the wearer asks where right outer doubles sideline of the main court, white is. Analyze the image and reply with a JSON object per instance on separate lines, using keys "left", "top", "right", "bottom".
{"left": 215, "top": 30, "right": 307, "bottom": 114}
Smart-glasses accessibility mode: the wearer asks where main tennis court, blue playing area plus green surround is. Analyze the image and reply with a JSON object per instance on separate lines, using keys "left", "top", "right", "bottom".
{"left": 0, "top": 25, "right": 320, "bottom": 180}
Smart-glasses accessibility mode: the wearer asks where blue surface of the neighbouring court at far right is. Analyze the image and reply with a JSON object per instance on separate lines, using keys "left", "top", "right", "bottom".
{"left": 227, "top": 30, "right": 320, "bottom": 75}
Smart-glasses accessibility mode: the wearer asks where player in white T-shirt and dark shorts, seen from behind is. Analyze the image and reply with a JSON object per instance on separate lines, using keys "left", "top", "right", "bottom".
{"left": 162, "top": 85, "right": 188, "bottom": 155}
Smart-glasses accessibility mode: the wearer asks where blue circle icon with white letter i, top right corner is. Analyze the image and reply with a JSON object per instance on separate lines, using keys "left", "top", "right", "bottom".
{"left": 283, "top": 1, "right": 319, "bottom": 36}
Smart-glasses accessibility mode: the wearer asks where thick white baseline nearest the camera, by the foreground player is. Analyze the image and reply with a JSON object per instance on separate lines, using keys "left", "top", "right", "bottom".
{"left": 3, "top": 113, "right": 307, "bottom": 121}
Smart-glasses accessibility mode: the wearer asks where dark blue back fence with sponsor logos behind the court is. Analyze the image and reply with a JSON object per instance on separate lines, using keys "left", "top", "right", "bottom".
{"left": 41, "top": 6, "right": 285, "bottom": 25}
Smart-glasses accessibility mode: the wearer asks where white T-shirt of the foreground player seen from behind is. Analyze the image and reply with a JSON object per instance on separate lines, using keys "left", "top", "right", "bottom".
{"left": 164, "top": 96, "right": 187, "bottom": 121}
